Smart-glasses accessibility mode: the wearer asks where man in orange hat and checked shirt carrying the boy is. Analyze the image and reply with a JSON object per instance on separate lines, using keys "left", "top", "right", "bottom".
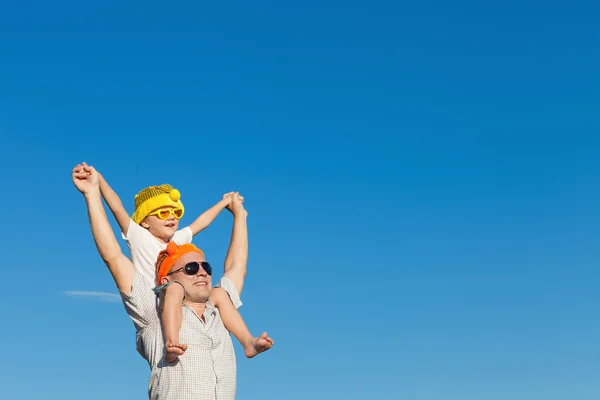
{"left": 73, "top": 165, "right": 253, "bottom": 400}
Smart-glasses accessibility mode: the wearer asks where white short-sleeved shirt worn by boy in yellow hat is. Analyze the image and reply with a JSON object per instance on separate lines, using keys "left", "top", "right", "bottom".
{"left": 121, "top": 219, "right": 193, "bottom": 285}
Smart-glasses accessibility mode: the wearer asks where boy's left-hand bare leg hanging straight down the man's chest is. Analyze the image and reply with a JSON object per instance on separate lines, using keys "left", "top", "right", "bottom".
{"left": 161, "top": 282, "right": 187, "bottom": 362}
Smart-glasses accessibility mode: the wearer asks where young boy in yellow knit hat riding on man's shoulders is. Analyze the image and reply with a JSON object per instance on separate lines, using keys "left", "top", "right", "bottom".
{"left": 90, "top": 164, "right": 274, "bottom": 362}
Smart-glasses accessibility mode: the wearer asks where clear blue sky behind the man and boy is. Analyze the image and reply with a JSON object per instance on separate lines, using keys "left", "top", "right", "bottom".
{"left": 0, "top": 0, "right": 600, "bottom": 400}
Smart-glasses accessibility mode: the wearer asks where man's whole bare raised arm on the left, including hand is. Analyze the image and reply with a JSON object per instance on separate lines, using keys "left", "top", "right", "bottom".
{"left": 73, "top": 163, "right": 135, "bottom": 295}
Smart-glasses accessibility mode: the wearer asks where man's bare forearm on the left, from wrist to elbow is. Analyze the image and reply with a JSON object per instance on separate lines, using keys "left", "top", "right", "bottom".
{"left": 85, "top": 191, "right": 122, "bottom": 263}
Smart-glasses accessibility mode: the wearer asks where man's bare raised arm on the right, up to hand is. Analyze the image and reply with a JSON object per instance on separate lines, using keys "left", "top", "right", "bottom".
{"left": 223, "top": 195, "right": 248, "bottom": 294}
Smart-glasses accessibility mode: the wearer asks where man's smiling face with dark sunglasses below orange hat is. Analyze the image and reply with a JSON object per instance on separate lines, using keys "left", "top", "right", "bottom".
{"left": 168, "top": 251, "right": 212, "bottom": 303}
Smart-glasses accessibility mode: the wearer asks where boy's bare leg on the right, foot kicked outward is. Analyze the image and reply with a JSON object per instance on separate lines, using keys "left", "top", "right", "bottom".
{"left": 210, "top": 288, "right": 274, "bottom": 358}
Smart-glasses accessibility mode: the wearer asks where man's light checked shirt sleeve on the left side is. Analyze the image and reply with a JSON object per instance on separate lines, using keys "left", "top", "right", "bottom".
{"left": 120, "top": 271, "right": 158, "bottom": 331}
